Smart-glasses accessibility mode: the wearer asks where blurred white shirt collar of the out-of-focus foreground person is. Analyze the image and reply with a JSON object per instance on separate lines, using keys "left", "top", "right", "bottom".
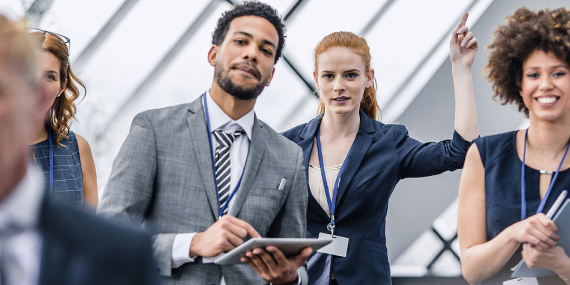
{"left": 0, "top": 166, "right": 45, "bottom": 228}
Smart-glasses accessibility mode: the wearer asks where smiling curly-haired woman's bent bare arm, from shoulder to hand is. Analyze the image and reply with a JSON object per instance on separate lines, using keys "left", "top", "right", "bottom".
{"left": 457, "top": 144, "right": 558, "bottom": 284}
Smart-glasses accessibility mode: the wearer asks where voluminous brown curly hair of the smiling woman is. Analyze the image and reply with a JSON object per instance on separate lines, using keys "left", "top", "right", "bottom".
{"left": 485, "top": 7, "right": 570, "bottom": 118}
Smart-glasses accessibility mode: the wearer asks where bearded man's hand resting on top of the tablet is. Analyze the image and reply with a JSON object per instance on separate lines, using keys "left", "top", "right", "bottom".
{"left": 189, "top": 215, "right": 261, "bottom": 258}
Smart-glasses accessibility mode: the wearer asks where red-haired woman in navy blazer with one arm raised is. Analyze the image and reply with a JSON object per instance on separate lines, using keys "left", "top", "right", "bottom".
{"left": 284, "top": 14, "right": 479, "bottom": 284}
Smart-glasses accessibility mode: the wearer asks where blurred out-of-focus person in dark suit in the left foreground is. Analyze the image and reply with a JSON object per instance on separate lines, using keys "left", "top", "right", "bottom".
{"left": 0, "top": 15, "right": 158, "bottom": 285}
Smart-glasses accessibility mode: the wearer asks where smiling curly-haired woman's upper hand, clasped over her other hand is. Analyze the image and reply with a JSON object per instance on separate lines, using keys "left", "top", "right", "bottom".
{"left": 511, "top": 213, "right": 559, "bottom": 251}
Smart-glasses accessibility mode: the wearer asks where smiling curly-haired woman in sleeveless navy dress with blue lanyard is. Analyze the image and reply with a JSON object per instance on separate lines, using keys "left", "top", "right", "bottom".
{"left": 458, "top": 8, "right": 570, "bottom": 284}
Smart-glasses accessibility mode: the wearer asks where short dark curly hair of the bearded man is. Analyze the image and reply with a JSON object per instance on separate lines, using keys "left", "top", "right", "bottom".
{"left": 212, "top": 1, "right": 285, "bottom": 63}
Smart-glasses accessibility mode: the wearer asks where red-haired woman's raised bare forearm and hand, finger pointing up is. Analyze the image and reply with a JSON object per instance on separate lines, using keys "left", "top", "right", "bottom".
{"left": 449, "top": 13, "right": 479, "bottom": 141}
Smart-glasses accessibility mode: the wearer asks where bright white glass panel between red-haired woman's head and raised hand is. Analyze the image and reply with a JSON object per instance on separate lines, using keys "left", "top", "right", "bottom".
{"left": 366, "top": 0, "right": 471, "bottom": 107}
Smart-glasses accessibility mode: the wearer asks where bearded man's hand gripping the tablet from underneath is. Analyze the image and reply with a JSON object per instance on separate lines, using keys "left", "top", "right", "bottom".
{"left": 241, "top": 246, "right": 313, "bottom": 285}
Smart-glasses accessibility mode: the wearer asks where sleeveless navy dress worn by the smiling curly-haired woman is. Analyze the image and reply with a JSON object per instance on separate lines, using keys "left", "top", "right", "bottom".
{"left": 475, "top": 131, "right": 570, "bottom": 285}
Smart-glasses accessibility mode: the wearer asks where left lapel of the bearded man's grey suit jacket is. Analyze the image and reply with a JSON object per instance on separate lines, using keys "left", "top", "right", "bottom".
{"left": 187, "top": 95, "right": 219, "bottom": 220}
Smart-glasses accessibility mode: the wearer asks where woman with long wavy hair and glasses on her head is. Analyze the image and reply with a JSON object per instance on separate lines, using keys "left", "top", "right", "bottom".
{"left": 30, "top": 29, "right": 98, "bottom": 208}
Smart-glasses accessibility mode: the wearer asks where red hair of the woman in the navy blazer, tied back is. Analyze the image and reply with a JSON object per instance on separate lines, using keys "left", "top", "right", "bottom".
{"left": 315, "top": 32, "right": 382, "bottom": 120}
